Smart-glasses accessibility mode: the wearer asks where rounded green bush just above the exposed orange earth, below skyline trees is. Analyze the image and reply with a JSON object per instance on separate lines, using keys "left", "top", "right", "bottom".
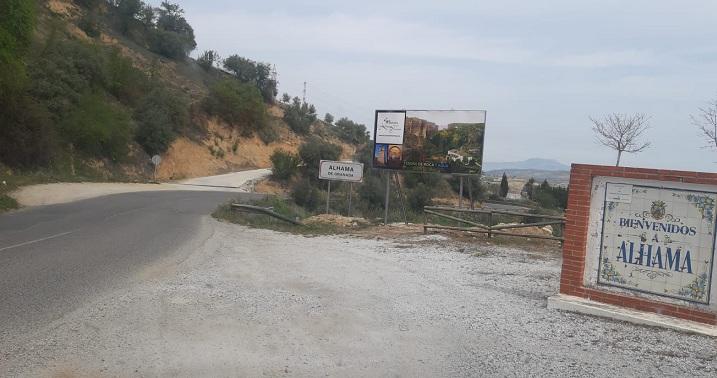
{"left": 204, "top": 79, "right": 267, "bottom": 131}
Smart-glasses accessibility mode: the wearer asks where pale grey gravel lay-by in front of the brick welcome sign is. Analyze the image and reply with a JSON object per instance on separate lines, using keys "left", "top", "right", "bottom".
{"left": 0, "top": 218, "right": 717, "bottom": 377}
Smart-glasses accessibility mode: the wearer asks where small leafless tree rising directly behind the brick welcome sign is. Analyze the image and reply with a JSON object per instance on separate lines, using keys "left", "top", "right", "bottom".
{"left": 590, "top": 113, "right": 650, "bottom": 166}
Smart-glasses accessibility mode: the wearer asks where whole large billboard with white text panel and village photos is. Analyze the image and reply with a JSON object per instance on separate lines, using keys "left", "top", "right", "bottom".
{"left": 373, "top": 110, "right": 486, "bottom": 175}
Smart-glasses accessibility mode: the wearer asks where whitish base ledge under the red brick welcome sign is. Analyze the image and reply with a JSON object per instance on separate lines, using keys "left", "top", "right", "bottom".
{"left": 548, "top": 294, "right": 717, "bottom": 337}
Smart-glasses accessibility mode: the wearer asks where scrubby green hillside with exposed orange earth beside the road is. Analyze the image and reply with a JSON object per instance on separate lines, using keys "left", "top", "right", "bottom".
{"left": 0, "top": 0, "right": 367, "bottom": 192}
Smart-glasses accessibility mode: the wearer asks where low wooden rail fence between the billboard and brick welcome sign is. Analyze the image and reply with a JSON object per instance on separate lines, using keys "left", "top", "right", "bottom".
{"left": 423, "top": 206, "right": 565, "bottom": 243}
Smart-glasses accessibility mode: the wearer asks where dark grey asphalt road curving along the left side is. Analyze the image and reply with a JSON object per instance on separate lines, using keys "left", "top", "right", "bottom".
{"left": 0, "top": 191, "right": 262, "bottom": 344}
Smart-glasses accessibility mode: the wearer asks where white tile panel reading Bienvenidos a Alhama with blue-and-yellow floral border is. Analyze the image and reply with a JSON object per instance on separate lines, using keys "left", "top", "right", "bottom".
{"left": 597, "top": 182, "right": 717, "bottom": 304}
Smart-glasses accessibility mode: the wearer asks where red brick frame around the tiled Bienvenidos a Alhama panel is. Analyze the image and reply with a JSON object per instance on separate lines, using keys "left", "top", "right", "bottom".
{"left": 560, "top": 164, "right": 717, "bottom": 325}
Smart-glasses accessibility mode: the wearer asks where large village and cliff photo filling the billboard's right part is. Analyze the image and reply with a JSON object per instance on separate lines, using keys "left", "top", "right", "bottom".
{"left": 402, "top": 110, "right": 486, "bottom": 175}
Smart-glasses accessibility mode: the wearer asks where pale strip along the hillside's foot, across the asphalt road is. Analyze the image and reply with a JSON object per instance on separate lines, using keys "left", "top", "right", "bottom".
{"left": 10, "top": 169, "right": 271, "bottom": 206}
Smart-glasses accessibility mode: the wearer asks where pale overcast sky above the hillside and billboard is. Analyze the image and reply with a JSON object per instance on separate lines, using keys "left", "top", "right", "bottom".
{"left": 171, "top": 0, "right": 717, "bottom": 171}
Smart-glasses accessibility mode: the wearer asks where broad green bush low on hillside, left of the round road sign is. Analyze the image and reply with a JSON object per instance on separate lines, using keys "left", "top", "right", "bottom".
{"left": 60, "top": 94, "right": 133, "bottom": 161}
